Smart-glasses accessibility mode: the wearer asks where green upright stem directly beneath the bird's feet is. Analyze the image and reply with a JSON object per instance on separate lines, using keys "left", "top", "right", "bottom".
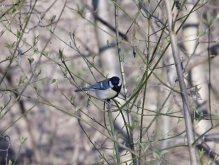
{"left": 106, "top": 100, "right": 120, "bottom": 164}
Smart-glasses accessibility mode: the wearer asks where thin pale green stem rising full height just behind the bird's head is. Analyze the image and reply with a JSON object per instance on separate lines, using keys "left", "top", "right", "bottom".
{"left": 114, "top": 0, "right": 138, "bottom": 165}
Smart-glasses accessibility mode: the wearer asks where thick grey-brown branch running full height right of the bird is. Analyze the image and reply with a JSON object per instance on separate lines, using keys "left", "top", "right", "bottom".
{"left": 164, "top": 0, "right": 198, "bottom": 165}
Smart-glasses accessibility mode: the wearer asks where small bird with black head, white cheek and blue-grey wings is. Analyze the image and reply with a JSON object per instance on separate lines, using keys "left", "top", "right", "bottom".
{"left": 75, "top": 76, "right": 122, "bottom": 100}
